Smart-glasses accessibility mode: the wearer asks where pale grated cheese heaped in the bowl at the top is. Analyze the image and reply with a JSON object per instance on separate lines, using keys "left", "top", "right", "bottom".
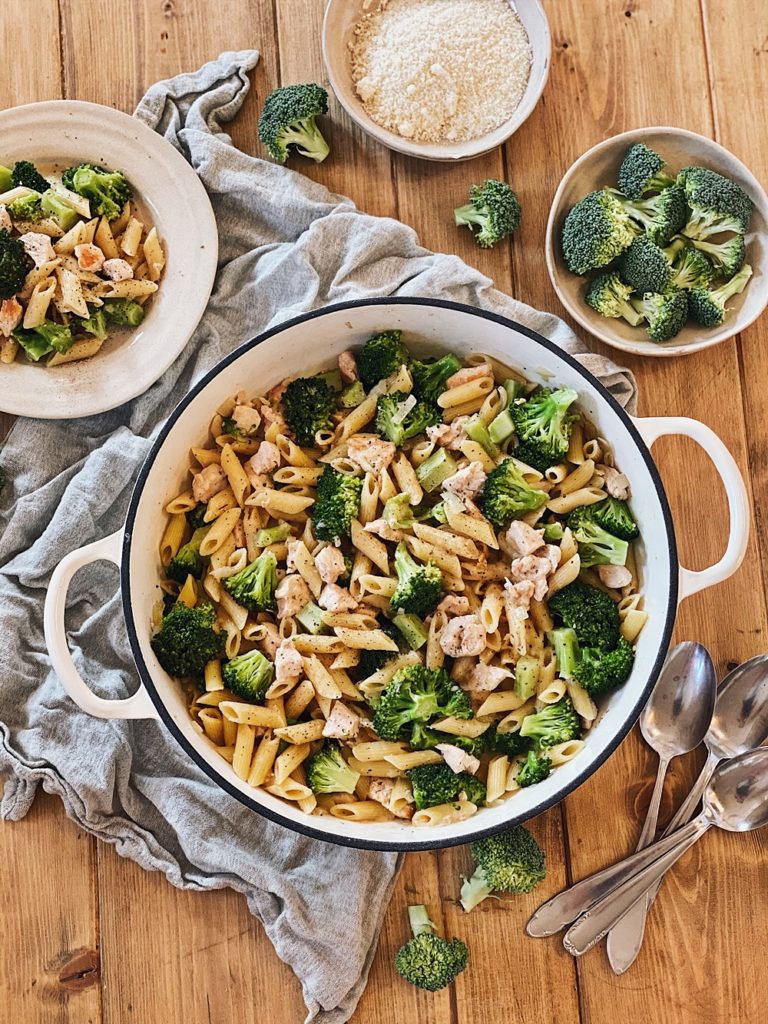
{"left": 349, "top": 0, "right": 530, "bottom": 142}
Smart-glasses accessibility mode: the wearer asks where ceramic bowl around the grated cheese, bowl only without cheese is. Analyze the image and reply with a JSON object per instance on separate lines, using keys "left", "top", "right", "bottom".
{"left": 323, "top": 0, "right": 552, "bottom": 162}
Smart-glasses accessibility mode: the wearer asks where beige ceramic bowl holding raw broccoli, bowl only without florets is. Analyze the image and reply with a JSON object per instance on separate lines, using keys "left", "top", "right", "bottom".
{"left": 546, "top": 128, "right": 768, "bottom": 355}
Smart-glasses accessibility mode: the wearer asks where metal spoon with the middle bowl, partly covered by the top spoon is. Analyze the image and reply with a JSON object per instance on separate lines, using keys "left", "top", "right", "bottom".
{"left": 607, "top": 654, "right": 768, "bottom": 974}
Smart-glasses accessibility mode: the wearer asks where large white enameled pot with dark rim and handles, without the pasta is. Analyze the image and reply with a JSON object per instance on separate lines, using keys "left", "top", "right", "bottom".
{"left": 45, "top": 299, "right": 750, "bottom": 850}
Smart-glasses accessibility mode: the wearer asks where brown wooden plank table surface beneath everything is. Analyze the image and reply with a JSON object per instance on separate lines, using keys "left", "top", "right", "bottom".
{"left": 0, "top": 0, "right": 768, "bottom": 1024}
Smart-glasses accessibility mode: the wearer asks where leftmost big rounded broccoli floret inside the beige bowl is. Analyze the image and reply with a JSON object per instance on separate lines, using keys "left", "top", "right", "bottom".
{"left": 562, "top": 188, "right": 640, "bottom": 273}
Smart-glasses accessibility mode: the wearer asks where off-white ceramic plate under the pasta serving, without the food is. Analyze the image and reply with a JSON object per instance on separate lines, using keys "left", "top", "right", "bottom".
{"left": 0, "top": 100, "right": 218, "bottom": 420}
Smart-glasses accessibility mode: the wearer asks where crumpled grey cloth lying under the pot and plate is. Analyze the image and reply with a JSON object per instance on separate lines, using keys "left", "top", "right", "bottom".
{"left": 0, "top": 50, "right": 635, "bottom": 1024}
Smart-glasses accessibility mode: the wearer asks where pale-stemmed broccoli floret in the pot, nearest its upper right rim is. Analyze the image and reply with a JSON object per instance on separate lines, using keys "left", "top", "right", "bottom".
{"left": 511, "top": 388, "right": 579, "bottom": 473}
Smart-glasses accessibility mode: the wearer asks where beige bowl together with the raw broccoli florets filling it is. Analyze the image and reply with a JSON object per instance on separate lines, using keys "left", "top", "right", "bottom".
{"left": 546, "top": 128, "right": 768, "bottom": 355}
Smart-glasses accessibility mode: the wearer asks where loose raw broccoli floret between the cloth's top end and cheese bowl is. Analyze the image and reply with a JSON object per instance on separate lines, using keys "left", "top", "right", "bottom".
{"left": 259, "top": 82, "right": 331, "bottom": 164}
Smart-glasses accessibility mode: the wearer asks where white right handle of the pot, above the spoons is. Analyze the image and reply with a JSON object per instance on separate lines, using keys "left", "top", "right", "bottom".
{"left": 634, "top": 416, "right": 750, "bottom": 601}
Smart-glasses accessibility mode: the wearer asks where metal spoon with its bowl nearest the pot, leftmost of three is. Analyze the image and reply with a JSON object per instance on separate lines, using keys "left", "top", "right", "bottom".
{"left": 525, "top": 641, "right": 717, "bottom": 938}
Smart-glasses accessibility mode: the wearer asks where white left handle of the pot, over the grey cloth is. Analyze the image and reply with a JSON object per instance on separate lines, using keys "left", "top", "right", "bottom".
{"left": 43, "top": 529, "right": 158, "bottom": 718}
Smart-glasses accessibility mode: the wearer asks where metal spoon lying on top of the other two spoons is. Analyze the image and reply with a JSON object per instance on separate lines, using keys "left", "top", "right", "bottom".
{"left": 563, "top": 746, "right": 768, "bottom": 956}
